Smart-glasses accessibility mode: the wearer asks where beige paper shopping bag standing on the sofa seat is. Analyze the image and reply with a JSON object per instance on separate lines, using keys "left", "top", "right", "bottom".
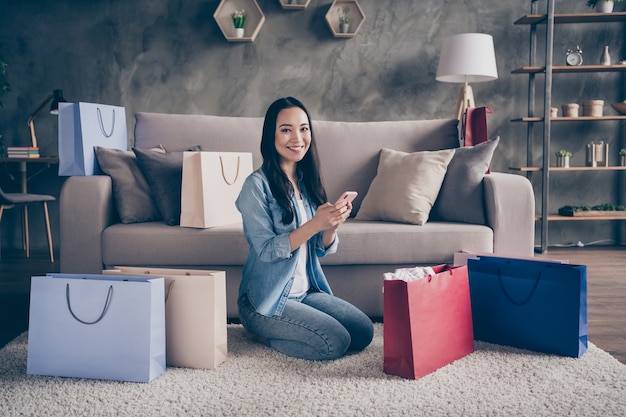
{"left": 180, "top": 152, "right": 252, "bottom": 228}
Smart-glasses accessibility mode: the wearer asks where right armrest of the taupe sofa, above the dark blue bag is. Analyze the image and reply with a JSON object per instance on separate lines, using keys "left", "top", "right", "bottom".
{"left": 484, "top": 172, "right": 535, "bottom": 256}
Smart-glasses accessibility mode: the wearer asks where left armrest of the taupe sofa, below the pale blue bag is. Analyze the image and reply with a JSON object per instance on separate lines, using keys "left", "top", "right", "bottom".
{"left": 59, "top": 175, "right": 117, "bottom": 274}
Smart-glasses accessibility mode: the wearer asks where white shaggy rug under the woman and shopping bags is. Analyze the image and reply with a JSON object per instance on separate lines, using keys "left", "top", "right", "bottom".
{"left": 0, "top": 324, "right": 626, "bottom": 417}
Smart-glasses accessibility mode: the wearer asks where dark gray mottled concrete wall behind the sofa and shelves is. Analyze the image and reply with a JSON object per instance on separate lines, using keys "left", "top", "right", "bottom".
{"left": 0, "top": 0, "right": 626, "bottom": 249}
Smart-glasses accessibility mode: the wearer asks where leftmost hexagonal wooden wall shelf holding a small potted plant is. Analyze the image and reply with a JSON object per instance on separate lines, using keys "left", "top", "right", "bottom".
{"left": 213, "top": 0, "right": 265, "bottom": 42}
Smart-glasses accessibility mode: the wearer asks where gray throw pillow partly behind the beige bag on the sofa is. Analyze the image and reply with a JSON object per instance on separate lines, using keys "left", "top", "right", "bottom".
{"left": 133, "top": 146, "right": 200, "bottom": 226}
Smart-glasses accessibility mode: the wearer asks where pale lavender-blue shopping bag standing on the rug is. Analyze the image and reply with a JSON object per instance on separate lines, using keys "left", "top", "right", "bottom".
{"left": 26, "top": 274, "right": 165, "bottom": 382}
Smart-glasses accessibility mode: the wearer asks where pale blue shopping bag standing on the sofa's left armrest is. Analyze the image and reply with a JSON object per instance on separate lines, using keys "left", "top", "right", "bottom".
{"left": 59, "top": 102, "right": 128, "bottom": 176}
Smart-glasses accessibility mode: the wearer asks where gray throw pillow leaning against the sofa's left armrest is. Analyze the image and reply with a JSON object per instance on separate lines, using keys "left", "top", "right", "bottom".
{"left": 94, "top": 146, "right": 161, "bottom": 224}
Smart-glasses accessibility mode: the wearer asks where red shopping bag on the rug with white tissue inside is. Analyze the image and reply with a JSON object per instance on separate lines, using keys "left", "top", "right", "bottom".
{"left": 383, "top": 265, "right": 474, "bottom": 379}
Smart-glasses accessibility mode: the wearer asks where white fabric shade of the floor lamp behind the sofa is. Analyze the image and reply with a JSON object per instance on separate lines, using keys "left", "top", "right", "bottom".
{"left": 436, "top": 33, "right": 498, "bottom": 83}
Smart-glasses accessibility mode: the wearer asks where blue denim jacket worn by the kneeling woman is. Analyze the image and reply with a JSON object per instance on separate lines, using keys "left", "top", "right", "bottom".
{"left": 236, "top": 169, "right": 338, "bottom": 316}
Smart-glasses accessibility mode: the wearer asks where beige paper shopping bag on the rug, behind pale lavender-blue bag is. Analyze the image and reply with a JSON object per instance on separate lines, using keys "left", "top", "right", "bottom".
{"left": 102, "top": 266, "right": 228, "bottom": 369}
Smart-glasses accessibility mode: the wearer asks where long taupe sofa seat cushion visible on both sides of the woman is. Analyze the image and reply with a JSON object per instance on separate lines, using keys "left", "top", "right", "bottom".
{"left": 102, "top": 219, "right": 493, "bottom": 264}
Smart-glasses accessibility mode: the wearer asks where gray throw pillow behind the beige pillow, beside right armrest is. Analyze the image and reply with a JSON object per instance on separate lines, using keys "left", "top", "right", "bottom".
{"left": 432, "top": 137, "right": 500, "bottom": 224}
